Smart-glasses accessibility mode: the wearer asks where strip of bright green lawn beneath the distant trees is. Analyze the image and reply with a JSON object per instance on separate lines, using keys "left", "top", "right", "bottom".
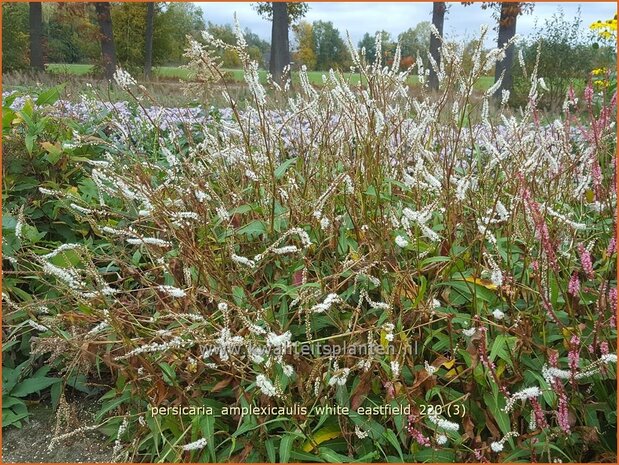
{"left": 47, "top": 63, "right": 494, "bottom": 91}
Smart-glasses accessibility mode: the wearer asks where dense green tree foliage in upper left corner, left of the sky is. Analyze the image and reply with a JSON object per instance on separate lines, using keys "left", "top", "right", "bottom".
{"left": 2, "top": 2, "right": 205, "bottom": 71}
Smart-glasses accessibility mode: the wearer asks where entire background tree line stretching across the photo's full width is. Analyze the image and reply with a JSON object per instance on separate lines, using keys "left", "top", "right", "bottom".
{"left": 2, "top": 2, "right": 614, "bottom": 109}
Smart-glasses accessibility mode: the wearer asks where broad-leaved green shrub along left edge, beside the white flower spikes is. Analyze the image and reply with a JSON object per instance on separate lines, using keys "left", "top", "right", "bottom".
{"left": 2, "top": 87, "right": 111, "bottom": 427}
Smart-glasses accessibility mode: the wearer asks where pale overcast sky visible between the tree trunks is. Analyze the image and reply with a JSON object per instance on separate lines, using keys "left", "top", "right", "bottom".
{"left": 199, "top": 2, "right": 617, "bottom": 46}
